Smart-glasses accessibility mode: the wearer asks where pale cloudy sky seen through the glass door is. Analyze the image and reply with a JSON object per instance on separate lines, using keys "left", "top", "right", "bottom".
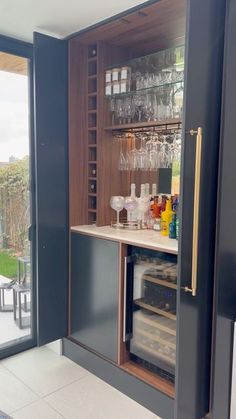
{"left": 0, "top": 71, "right": 29, "bottom": 162}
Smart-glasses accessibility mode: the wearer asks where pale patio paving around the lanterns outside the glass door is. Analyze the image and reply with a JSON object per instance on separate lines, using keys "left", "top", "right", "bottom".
{"left": 0, "top": 275, "right": 30, "bottom": 347}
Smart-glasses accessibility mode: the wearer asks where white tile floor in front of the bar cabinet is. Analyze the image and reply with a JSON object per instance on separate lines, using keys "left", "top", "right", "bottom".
{"left": 0, "top": 347, "right": 158, "bottom": 419}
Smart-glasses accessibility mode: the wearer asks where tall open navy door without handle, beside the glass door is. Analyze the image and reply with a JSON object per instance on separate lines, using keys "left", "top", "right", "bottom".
{"left": 34, "top": 33, "right": 68, "bottom": 345}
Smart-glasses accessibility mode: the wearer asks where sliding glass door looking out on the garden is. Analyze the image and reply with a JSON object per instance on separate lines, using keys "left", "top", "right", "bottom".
{"left": 0, "top": 38, "right": 35, "bottom": 357}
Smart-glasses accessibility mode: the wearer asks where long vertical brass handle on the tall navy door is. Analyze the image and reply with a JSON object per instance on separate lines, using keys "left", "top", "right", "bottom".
{"left": 184, "top": 127, "right": 202, "bottom": 297}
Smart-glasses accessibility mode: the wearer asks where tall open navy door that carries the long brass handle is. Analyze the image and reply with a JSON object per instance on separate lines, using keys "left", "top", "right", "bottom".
{"left": 175, "top": 0, "right": 225, "bottom": 419}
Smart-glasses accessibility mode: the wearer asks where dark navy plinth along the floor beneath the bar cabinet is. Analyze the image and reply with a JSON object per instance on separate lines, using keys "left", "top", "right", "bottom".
{"left": 63, "top": 339, "right": 174, "bottom": 419}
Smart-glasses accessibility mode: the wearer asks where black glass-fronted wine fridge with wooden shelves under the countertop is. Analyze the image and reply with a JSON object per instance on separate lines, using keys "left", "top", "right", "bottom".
{"left": 123, "top": 247, "right": 177, "bottom": 382}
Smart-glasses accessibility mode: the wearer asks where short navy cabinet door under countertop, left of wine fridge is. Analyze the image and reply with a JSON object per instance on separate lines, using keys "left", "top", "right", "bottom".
{"left": 70, "top": 233, "right": 119, "bottom": 362}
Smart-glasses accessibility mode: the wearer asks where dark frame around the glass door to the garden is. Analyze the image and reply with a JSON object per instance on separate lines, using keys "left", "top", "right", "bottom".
{"left": 0, "top": 35, "right": 37, "bottom": 359}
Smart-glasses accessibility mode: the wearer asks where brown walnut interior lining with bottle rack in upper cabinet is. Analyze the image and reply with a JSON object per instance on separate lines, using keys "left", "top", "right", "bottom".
{"left": 69, "top": 0, "right": 186, "bottom": 226}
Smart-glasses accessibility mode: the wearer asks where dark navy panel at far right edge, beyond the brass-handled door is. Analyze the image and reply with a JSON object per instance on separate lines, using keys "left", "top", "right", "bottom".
{"left": 212, "top": 0, "right": 236, "bottom": 419}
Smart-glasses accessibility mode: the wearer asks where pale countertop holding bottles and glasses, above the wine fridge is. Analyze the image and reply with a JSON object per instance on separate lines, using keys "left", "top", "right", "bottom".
{"left": 71, "top": 225, "right": 178, "bottom": 254}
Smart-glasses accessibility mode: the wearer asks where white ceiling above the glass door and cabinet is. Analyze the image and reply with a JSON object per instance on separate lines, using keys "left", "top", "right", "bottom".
{"left": 0, "top": 0, "right": 146, "bottom": 42}
